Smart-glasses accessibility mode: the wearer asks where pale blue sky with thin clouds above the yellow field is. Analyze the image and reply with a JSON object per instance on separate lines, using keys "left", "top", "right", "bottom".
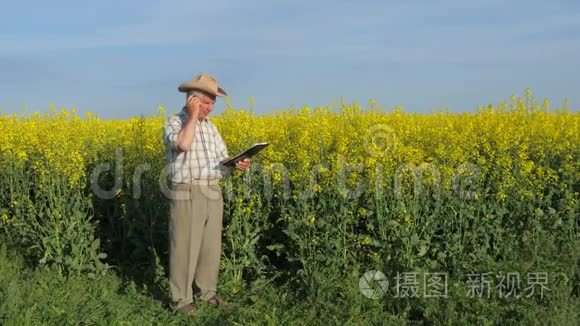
{"left": 0, "top": 0, "right": 580, "bottom": 118}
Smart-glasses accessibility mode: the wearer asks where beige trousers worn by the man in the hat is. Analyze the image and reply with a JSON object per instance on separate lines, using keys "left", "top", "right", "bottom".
{"left": 169, "top": 184, "right": 223, "bottom": 308}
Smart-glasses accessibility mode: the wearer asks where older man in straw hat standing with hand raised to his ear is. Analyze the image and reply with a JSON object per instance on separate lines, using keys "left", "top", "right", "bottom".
{"left": 164, "top": 74, "right": 250, "bottom": 316}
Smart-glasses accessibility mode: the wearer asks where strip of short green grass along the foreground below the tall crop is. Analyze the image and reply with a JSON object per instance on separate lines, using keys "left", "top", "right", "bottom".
{"left": 0, "top": 242, "right": 580, "bottom": 326}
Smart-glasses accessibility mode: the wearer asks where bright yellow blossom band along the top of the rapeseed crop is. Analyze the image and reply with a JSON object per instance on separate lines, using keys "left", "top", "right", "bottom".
{"left": 0, "top": 90, "right": 580, "bottom": 200}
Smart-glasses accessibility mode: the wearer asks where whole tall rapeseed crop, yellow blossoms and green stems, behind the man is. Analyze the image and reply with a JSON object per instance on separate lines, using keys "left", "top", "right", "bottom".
{"left": 0, "top": 93, "right": 580, "bottom": 320}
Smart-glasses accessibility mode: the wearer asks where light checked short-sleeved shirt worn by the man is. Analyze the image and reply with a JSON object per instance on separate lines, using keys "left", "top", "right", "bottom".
{"left": 163, "top": 108, "right": 231, "bottom": 183}
